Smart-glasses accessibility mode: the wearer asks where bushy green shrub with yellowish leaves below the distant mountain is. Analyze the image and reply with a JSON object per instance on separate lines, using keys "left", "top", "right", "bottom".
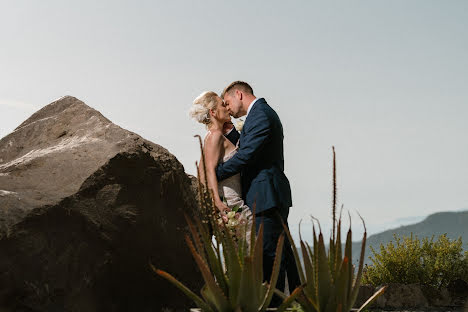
{"left": 363, "top": 234, "right": 468, "bottom": 289}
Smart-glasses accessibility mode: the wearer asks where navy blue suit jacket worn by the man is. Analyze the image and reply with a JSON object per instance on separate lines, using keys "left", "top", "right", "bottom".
{"left": 216, "top": 98, "right": 292, "bottom": 213}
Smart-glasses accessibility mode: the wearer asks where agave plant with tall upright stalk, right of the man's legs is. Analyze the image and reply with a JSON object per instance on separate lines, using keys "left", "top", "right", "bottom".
{"left": 284, "top": 148, "right": 385, "bottom": 312}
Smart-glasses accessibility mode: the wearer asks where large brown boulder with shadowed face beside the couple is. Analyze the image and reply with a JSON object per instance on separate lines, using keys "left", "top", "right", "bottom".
{"left": 0, "top": 96, "right": 201, "bottom": 311}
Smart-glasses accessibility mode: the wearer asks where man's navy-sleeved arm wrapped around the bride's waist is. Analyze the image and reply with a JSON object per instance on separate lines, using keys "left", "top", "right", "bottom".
{"left": 216, "top": 111, "right": 271, "bottom": 181}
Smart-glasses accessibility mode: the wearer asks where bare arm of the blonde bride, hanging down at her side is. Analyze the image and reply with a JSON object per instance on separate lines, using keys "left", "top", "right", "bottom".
{"left": 205, "top": 132, "right": 229, "bottom": 211}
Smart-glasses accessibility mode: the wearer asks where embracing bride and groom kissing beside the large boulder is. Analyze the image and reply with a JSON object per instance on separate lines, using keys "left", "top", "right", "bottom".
{"left": 190, "top": 81, "right": 299, "bottom": 306}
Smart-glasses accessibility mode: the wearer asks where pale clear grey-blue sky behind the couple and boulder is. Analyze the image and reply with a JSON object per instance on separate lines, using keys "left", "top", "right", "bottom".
{"left": 0, "top": 0, "right": 468, "bottom": 236}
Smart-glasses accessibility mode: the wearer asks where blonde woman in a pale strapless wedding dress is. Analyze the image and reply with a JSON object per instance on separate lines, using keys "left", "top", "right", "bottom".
{"left": 190, "top": 91, "right": 251, "bottom": 219}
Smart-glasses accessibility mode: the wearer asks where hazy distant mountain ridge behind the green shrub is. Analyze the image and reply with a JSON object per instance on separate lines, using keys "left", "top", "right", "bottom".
{"left": 353, "top": 210, "right": 468, "bottom": 264}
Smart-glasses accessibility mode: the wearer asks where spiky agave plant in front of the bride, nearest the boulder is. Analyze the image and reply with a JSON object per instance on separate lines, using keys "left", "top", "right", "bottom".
{"left": 150, "top": 136, "right": 302, "bottom": 312}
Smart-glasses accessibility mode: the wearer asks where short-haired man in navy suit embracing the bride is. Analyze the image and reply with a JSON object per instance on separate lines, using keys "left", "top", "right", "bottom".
{"left": 216, "top": 81, "right": 299, "bottom": 306}
